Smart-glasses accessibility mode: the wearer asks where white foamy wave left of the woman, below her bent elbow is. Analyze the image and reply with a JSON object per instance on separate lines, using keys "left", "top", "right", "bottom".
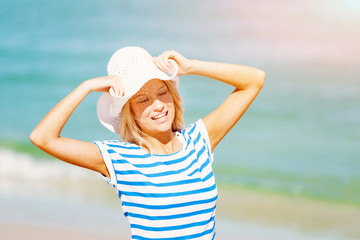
{"left": 0, "top": 149, "right": 108, "bottom": 199}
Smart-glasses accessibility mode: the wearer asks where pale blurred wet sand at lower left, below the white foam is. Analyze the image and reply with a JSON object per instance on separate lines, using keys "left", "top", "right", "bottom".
{"left": 0, "top": 188, "right": 130, "bottom": 240}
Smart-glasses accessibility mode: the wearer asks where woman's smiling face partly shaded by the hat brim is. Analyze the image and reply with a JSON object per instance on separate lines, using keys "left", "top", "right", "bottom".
{"left": 129, "top": 79, "right": 175, "bottom": 136}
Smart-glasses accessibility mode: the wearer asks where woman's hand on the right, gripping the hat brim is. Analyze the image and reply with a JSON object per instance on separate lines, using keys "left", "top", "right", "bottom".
{"left": 153, "top": 50, "right": 191, "bottom": 76}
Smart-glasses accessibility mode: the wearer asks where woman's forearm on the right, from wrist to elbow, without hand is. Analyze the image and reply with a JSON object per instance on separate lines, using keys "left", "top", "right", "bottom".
{"left": 187, "top": 60, "right": 265, "bottom": 90}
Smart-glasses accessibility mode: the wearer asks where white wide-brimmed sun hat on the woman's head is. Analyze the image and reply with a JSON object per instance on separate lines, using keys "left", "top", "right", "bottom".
{"left": 97, "top": 47, "right": 179, "bottom": 133}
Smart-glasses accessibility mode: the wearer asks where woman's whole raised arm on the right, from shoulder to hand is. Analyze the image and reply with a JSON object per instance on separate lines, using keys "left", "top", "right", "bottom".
{"left": 154, "top": 51, "right": 265, "bottom": 150}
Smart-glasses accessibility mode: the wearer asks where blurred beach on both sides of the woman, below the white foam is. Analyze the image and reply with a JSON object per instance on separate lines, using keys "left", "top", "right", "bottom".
{"left": 0, "top": 180, "right": 360, "bottom": 240}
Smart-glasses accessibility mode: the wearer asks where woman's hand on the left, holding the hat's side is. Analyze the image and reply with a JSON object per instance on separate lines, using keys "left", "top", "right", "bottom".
{"left": 85, "top": 74, "right": 125, "bottom": 97}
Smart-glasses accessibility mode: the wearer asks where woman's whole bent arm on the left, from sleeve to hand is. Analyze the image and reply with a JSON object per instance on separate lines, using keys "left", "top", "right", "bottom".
{"left": 30, "top": 75, "right": 121, "bottom": 177}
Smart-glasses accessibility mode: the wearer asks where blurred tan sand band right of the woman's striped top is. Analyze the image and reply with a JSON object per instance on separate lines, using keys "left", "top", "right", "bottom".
{"left": 217, "top": 186, "right": 360, "bottom": 239}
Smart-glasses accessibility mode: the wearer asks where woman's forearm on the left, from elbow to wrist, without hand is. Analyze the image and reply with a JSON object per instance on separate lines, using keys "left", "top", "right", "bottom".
{"left": 30, "top": 82, "right": 91, "bottom": 147}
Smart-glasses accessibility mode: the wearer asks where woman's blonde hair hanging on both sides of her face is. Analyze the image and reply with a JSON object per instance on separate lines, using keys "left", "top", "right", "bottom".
{"left": 119, "top": 81, "right": 184, "bottom": 147}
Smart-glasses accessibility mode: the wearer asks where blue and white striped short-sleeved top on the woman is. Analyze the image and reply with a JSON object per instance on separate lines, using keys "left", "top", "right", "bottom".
{"left": 95, "top": 119, "right": 217, "bottom": 240}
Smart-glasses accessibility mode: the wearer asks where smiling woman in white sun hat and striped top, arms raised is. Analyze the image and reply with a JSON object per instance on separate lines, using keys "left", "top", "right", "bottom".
{"left": 30, "top": 47, "right": 265, "bottom": 240}
